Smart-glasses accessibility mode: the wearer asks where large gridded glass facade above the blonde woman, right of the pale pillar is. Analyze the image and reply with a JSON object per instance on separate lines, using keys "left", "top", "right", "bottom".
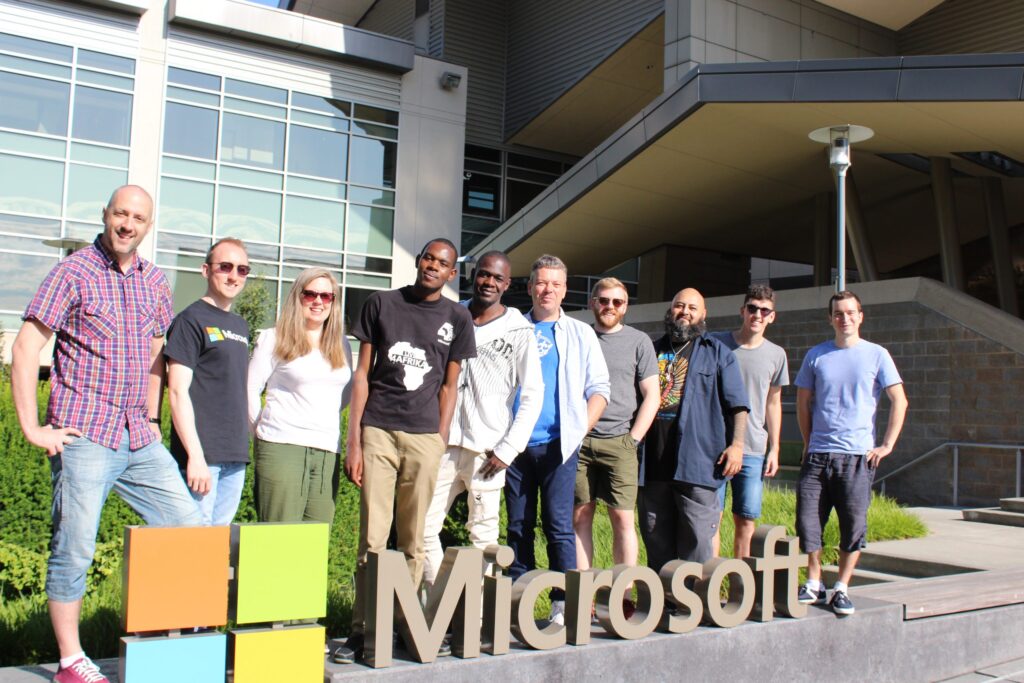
{"left": 157, "top": 67, "right": 398, "bottom": 327}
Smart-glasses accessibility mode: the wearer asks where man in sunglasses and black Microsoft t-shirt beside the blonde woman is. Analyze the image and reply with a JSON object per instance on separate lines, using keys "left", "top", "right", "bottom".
{"left": 164, "top": 238, "right": 249, "bottom": 526}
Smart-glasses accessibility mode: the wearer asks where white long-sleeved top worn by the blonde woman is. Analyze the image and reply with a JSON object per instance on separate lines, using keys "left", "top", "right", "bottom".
{"left": 248, "top": 328, "right": 352, "bottom": 453}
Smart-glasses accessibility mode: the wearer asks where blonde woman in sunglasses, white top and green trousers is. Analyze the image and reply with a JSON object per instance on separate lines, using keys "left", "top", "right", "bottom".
{"left": 249, "top": 268, "right": 352, "bottom": 523}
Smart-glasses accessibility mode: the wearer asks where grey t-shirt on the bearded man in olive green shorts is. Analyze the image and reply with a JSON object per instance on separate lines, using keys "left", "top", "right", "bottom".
{"left": 590, "top": 325, "right": 657, "bottom": 438}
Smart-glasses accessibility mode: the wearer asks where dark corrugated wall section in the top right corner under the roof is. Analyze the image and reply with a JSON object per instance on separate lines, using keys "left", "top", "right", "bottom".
{"left": 896, "top": 0, "right": 1024, "bottom": 54}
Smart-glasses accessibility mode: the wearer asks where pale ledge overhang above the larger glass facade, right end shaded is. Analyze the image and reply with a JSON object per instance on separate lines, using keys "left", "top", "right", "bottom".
{"left": 168, "top": 0, "right": 416, "bottom": 74}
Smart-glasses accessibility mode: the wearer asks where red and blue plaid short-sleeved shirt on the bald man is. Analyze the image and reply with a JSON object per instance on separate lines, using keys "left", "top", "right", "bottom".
{"left": 23, "top": 237, "right": 174, "bottom": 451}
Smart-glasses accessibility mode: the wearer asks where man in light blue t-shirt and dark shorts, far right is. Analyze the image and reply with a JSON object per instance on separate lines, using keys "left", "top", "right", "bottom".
{"left": 795, "top": 291, "right": 907, "bottom": 615}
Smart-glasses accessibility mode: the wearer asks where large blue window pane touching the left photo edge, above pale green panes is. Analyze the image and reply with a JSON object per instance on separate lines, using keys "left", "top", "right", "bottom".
{"left": 0, "top": 72, "right": 71, "bottom": 135}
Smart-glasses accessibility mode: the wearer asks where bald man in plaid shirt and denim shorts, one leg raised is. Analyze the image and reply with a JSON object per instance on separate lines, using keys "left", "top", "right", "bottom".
{"left": 11, "top": 185, "right": 202, "bottom": 683}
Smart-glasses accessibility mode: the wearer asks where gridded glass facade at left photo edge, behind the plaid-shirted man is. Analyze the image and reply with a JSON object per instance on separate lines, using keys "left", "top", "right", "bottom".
{"left": 0, "top": 33, "right": 135, "bottom": 334}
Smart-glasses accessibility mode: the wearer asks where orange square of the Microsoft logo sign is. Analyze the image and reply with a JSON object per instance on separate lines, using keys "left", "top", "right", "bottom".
{"left": 121, "top": 526, "right": 230, "bottom": 633}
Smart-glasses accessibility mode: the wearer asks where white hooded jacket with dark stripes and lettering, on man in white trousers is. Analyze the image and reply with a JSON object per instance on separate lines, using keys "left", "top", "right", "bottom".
{"left": 449, "top": 301, "right": 544, "bottom": 465}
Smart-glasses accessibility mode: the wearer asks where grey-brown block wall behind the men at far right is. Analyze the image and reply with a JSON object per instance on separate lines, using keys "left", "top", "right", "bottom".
{"left": 636, "top": 299, "right": 1024, "bottom": 505}
